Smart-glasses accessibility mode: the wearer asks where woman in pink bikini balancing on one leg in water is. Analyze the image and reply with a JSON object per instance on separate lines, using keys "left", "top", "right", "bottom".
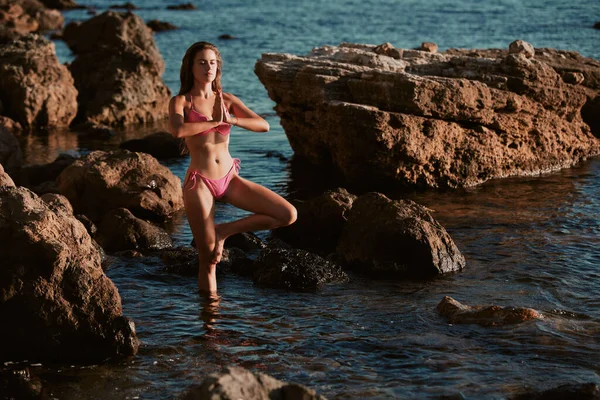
{"left": 169, "top": 42, "right": 296, "bottom": 295}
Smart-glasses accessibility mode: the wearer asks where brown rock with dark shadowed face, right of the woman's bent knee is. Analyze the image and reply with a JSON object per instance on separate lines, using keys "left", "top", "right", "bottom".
{"left": 336, "top": 193, "right": 465, "bottom": 278}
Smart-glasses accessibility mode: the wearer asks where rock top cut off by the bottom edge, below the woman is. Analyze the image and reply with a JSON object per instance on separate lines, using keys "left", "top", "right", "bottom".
{"left": 182, "top": 366, "right": 325, "bottom": 400}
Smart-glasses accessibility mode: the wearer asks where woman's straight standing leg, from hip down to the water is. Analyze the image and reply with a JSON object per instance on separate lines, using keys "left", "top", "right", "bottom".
{"left": 183, "top": 179, "right": 217, "bottom": 296}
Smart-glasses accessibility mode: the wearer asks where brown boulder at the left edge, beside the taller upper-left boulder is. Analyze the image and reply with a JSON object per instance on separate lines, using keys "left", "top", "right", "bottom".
{"left": 0, "top": 34, "right": 77, "bottom": 128}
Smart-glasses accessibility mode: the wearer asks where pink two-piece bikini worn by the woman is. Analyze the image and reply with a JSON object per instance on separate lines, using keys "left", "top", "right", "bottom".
{"left": 183, "top": 95, "right": 240, "bottom": 200}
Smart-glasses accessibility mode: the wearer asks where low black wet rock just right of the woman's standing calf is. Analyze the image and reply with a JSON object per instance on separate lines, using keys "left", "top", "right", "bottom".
{"left": 254, "top": 248, "right": 348, "bottom": 291}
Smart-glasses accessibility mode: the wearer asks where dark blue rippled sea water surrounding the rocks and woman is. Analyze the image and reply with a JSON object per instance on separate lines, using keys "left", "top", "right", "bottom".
{"left": 16, "top": 0, "right": 600, "bottom": 400}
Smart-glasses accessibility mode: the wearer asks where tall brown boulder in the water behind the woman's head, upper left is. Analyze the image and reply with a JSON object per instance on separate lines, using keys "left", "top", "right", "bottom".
{"left": 65, "top": 11, "right": 171, "bottom": 126}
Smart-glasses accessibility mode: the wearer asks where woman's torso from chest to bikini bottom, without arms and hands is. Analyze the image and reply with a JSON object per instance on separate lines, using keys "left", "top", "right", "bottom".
{"left": 184, "top": 95, "right": 233, "bottom": 179}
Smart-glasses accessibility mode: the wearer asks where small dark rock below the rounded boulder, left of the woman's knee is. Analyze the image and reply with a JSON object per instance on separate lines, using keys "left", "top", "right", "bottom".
{"left": 95, "top": 208, "right": 173, "bottom": 253}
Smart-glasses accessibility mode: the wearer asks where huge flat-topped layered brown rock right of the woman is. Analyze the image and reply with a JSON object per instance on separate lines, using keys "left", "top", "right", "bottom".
{"left": 255, "top": 43, "right": 600, "bottom": 189}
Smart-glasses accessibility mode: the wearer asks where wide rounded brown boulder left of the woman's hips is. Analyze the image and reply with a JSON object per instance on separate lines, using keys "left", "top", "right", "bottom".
{"left": 56, "top": 150, "right": 183, "bottom": 222}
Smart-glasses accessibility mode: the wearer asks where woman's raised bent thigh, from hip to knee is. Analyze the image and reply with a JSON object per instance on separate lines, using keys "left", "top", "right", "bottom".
{"left": 222, "top": 175, "right": 296, "bottom": 220}
